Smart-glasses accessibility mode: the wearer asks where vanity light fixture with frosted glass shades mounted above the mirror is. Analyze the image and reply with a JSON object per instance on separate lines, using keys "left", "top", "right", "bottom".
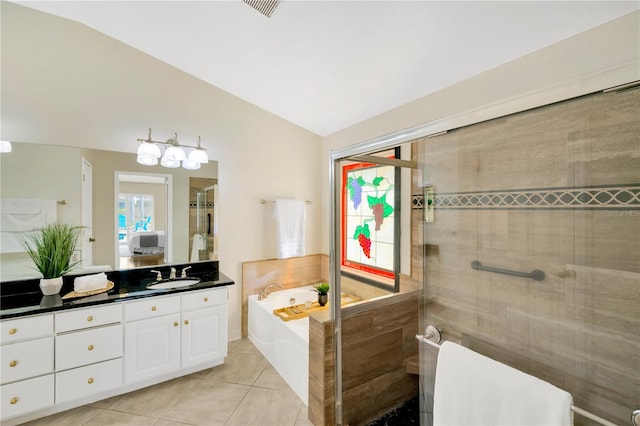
{"left": 137, "top": 129, "right": 209, "bottom": 170}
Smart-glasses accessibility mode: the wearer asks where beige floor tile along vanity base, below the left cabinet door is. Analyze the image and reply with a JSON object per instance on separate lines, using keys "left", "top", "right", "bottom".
{"left": 112, "top": 377, "right": 198, "bottom": 418}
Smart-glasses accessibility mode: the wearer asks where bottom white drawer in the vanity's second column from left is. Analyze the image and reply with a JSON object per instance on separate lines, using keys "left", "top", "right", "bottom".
{"left": 56, "top": 358, "right": 122, "bottom": 404}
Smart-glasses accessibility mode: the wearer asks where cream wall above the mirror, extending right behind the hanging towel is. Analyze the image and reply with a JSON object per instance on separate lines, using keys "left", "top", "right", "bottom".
{"left": 0, "top": 2, "right": 321, "bottom": 339}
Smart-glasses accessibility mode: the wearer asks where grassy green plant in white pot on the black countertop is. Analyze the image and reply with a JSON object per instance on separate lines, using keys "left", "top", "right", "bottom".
{"left": 24, "top": 222, "right": 80, "bottom": 296}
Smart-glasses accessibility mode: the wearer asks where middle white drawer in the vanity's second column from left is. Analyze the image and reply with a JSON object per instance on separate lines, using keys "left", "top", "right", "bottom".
{"left": 56, "top": 324, "right": 123, "bottom": 371}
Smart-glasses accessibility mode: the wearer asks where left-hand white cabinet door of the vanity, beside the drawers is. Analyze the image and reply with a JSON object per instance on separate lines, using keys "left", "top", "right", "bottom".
{"left": 124, "top": 314, "right": 180, "bottom": 384}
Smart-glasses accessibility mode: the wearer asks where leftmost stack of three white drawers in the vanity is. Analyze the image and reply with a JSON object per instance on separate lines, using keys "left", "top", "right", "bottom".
{"left": 0, "top": 314, "right": 54, "bottom": 423}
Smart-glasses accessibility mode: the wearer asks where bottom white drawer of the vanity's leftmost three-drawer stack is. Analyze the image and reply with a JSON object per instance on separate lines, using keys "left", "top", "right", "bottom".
{"left": 0, "top": 374, "right": 53, "bottom": 420}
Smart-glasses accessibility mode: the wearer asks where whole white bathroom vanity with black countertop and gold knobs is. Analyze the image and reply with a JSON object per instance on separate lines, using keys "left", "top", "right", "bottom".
{"left": 0, "top": 261, "right": 234, "bottom": 425}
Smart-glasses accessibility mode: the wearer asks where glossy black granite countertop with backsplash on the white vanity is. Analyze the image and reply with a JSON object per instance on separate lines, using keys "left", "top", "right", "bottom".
{"left": 0, "top": 261, "right": 234, "bottom": 319}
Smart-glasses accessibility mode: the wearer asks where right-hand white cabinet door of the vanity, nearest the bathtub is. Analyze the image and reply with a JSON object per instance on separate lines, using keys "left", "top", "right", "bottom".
{"left": 182, "top": 306, "right": 227, "bottom": 367}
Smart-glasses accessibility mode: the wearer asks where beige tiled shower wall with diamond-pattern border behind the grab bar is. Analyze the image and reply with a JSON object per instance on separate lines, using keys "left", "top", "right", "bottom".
{"left": 420, "top": 90, "right": 640, "bottom": 424}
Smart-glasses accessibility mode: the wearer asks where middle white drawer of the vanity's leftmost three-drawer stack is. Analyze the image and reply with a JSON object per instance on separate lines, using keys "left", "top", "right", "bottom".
{"left": 0, "top": 337, "right": 53, "bottom": 384}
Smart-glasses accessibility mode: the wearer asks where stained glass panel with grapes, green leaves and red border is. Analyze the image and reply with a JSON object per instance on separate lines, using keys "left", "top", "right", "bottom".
{"left": 343, "top": 164, "right": 395, "bottom": 277}
